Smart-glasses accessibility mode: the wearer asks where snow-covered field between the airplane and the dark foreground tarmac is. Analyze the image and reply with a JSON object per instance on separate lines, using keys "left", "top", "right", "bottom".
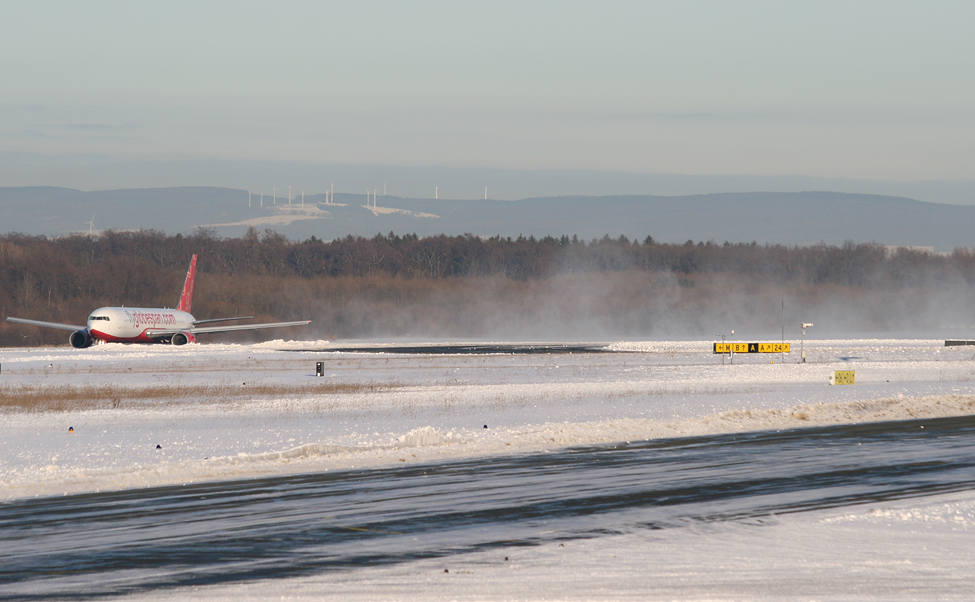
{"left": 0, "top": 340, "right": 975, "bottom": 499}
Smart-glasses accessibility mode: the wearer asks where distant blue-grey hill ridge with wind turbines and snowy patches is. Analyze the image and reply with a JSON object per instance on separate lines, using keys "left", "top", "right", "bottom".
{"left": 0, "top": 187, "right": 975, "bottom": 251}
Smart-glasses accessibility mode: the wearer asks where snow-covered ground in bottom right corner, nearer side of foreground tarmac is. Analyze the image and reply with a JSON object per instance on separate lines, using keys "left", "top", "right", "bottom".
{"left": 124, "top": 494, "right": 975, "bottom": 602}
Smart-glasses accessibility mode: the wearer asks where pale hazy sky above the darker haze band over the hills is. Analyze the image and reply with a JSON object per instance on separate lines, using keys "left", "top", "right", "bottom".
{"left": 0, "top": 0, "right": 975, "bottom": 185}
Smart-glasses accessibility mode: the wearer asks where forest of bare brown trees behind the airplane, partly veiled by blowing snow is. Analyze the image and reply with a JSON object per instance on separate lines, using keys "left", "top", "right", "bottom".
{"left": 0, "top": 229, "right": 975, "bottom": 346}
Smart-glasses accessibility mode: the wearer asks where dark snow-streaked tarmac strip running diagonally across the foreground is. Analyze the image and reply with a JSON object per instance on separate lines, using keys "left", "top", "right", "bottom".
{"left": 0, "top": 417, "right": 975, "bottom": 600}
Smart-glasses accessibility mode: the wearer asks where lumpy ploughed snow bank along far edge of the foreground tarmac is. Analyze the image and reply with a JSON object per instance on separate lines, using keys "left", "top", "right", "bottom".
{"left": 0, "top": 395, "right": 975, "bottom": 499}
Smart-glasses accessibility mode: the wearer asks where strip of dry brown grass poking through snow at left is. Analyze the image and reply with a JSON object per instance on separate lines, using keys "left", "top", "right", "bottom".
{"left": 0, "top": 381, "right": 405, "bottom": 412}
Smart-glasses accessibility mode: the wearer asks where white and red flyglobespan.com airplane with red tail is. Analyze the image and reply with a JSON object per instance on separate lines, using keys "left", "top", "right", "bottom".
{"left": 7, "top": 255, "right": 311, "bottom": 349}
